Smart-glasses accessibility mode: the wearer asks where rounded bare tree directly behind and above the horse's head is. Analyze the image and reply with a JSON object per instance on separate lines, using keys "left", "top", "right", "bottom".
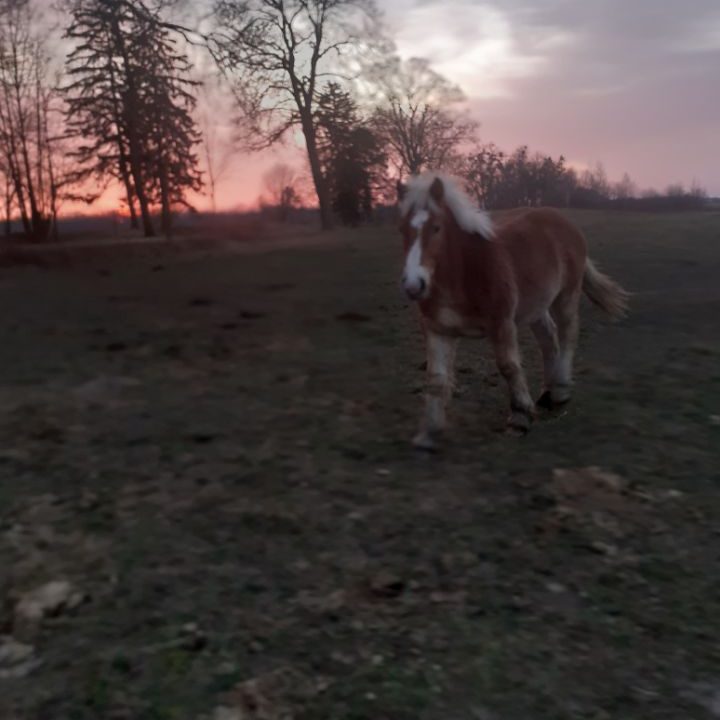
{"left": 373, "top": 58, "right": 478, "bottom": 179}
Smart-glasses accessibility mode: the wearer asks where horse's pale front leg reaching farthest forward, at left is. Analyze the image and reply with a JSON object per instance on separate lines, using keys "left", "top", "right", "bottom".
{"left": 413, "top": 330, "right": 457, "bottom": 451}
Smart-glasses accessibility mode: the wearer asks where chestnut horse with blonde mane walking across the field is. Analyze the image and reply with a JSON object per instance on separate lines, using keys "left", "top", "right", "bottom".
{"left": 399, "top": 172, "right": 629, "bottom": 451}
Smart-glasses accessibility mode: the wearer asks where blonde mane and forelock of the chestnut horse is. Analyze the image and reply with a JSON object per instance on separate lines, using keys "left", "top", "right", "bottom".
{"left": 400, "top": 172, "right": 495, "bottom": 239}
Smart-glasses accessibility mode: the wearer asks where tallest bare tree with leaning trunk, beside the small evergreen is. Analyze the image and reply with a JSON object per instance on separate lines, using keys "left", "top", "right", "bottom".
{"left": 210, "top": 0, "right": 378, "bottom": 228}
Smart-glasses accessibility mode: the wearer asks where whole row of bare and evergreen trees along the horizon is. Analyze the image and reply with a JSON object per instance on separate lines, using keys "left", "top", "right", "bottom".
{"left": 0, "top": 0, "right": 703, "bottom": 240}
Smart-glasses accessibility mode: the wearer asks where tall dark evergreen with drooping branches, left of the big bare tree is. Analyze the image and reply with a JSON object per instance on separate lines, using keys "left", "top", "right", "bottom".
{"left": 66, "top": 0, "right": 202, "bottom": 236}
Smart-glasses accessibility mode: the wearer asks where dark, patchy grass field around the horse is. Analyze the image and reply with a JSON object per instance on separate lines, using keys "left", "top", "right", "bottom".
{"left": 0, "top": 213, "right": 720, "bottom": 720}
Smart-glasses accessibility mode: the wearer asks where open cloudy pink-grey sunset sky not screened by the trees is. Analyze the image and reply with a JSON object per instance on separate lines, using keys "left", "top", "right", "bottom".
{"left": 83, "top": 0, "right": 720, "bottom": 214}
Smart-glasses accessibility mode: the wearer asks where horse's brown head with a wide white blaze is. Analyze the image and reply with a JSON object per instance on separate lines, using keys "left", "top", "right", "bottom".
{"left": 400, "top": 177, "right": 446, "bottom": 300}
